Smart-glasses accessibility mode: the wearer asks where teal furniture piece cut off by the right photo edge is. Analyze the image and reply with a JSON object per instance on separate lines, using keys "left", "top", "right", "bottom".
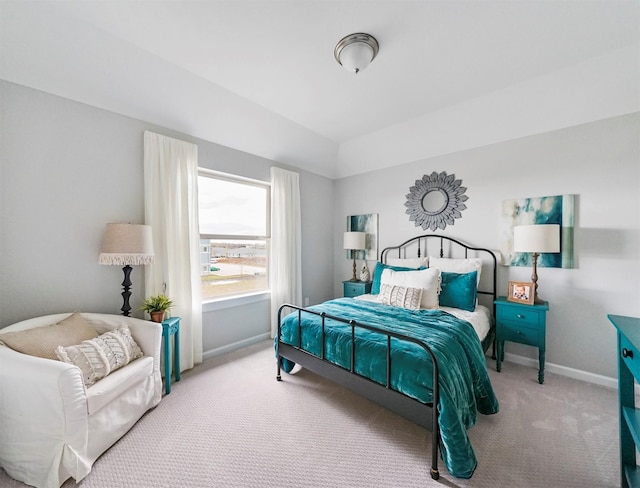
{"left": 608, "top": 315, "right": 640, "bottom": 488}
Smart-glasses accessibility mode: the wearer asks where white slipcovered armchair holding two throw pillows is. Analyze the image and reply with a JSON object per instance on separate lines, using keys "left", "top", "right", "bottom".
{"left": 0, "top": 313, "right": 162, "bottom": 488}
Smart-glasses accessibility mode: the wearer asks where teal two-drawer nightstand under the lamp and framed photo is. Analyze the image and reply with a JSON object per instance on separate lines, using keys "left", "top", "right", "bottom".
{"left": 495, "top": 297, "right": 549, "bottom": 384}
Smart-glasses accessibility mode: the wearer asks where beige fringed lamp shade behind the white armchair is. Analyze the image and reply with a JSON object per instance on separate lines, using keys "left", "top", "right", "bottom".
{"left": 98, "top": 224, "right": 153, "bottom": 266}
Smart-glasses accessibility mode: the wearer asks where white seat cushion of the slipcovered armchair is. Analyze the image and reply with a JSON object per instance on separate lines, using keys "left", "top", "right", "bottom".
{"left": 87, "top": 356, "right": 153, "bottom": 415}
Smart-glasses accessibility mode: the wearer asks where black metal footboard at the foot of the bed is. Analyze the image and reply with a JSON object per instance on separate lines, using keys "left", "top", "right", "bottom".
{"left": 276, "top": 304, "right": 440, "bottom": 480}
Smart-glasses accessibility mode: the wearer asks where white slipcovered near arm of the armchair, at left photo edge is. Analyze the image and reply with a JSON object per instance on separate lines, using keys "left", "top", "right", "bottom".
{"left": 0, "top": 346, "right": 90, "bottom": 485}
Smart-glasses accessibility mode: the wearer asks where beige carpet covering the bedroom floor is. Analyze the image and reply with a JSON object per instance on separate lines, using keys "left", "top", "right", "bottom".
{"left": 0, "top": 341, "right": 619, "bottom": 488}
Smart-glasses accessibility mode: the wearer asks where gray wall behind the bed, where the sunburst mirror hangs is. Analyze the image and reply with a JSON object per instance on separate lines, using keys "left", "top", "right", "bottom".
{"left": 333, "top": 113, "right": 640, "bottom": 377}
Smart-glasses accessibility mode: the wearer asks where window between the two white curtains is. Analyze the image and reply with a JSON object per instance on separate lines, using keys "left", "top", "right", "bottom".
{"left": 198, "top": 169, "right": 270, "bottom": 302}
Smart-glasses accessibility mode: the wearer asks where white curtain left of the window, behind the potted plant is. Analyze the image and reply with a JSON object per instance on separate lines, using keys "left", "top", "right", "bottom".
{"left": 144, "top": 131, "right": 202, "bottom": 370}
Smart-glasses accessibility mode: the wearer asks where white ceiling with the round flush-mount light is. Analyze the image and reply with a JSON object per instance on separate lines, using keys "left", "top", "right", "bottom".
{"left": 0, "top": 0, "right": 640, "bottom": 177}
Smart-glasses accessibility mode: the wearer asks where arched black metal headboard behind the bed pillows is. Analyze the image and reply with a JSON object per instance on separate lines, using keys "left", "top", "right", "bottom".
{"left": 380, "top": 234, "right": 498, "bottom": 317}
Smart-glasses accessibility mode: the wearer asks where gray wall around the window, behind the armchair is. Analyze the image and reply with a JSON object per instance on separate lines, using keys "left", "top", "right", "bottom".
{"left": 0, "top": 81, "right": 334, "bottom": 351}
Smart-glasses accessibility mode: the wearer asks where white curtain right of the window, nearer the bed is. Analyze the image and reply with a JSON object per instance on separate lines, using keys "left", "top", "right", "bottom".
{"left": 269, "top": 167, "right": 302, "bottom": 337}
